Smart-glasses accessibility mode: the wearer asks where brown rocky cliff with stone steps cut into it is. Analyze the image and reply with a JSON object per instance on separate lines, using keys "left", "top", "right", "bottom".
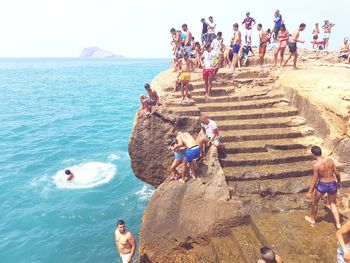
{"left": 129, "top": 51, "right": 350, "bottom": 263}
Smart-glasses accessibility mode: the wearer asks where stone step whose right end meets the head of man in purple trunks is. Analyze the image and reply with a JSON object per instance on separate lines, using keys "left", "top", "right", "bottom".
{"left": 221, "top": 150, "right": 314, "bottom": 168}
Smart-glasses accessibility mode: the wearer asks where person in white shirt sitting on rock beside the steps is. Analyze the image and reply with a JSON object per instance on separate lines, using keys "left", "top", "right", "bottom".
{"left": 199, "top": 115, "right": 220, "bottom": 157}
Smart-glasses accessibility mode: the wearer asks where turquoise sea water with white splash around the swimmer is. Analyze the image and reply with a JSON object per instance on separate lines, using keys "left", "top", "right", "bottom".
{"left": 0, "top": 59, "right": 169, "bottom": 262}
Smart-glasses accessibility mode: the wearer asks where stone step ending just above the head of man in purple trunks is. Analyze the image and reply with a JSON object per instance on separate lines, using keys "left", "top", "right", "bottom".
{"left": 222, "top": 138, "right": 308, "bottom": 154}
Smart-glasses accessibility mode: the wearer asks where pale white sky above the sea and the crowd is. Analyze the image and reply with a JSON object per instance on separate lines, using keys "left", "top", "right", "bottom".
{"left": 0, "top": 0, "right": 350, "bottom": 58}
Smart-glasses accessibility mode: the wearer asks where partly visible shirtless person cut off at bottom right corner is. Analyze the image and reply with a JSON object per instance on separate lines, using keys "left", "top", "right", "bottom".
{"left": 336, "top": 220, "right": 350, "bottom": 263}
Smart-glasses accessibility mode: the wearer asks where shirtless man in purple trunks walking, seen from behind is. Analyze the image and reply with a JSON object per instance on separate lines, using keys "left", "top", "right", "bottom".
{"left": 305, "top": 146, "right": 341, "bottom": 229}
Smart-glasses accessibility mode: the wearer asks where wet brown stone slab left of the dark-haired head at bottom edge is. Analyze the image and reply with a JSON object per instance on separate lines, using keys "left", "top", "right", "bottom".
{"left": 231, "top": 225, "right": 262, "bottom": 263}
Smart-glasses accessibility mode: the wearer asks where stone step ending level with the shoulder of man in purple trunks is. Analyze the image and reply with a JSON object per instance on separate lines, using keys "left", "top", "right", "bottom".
{"left": 223, "top": 161, "right": 314, "bottom": 181}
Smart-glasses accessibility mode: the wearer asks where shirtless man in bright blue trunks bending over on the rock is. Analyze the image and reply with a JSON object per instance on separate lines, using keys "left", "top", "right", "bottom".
{"left": 174, "top": 132, "right": 201, "bottom": 184}
